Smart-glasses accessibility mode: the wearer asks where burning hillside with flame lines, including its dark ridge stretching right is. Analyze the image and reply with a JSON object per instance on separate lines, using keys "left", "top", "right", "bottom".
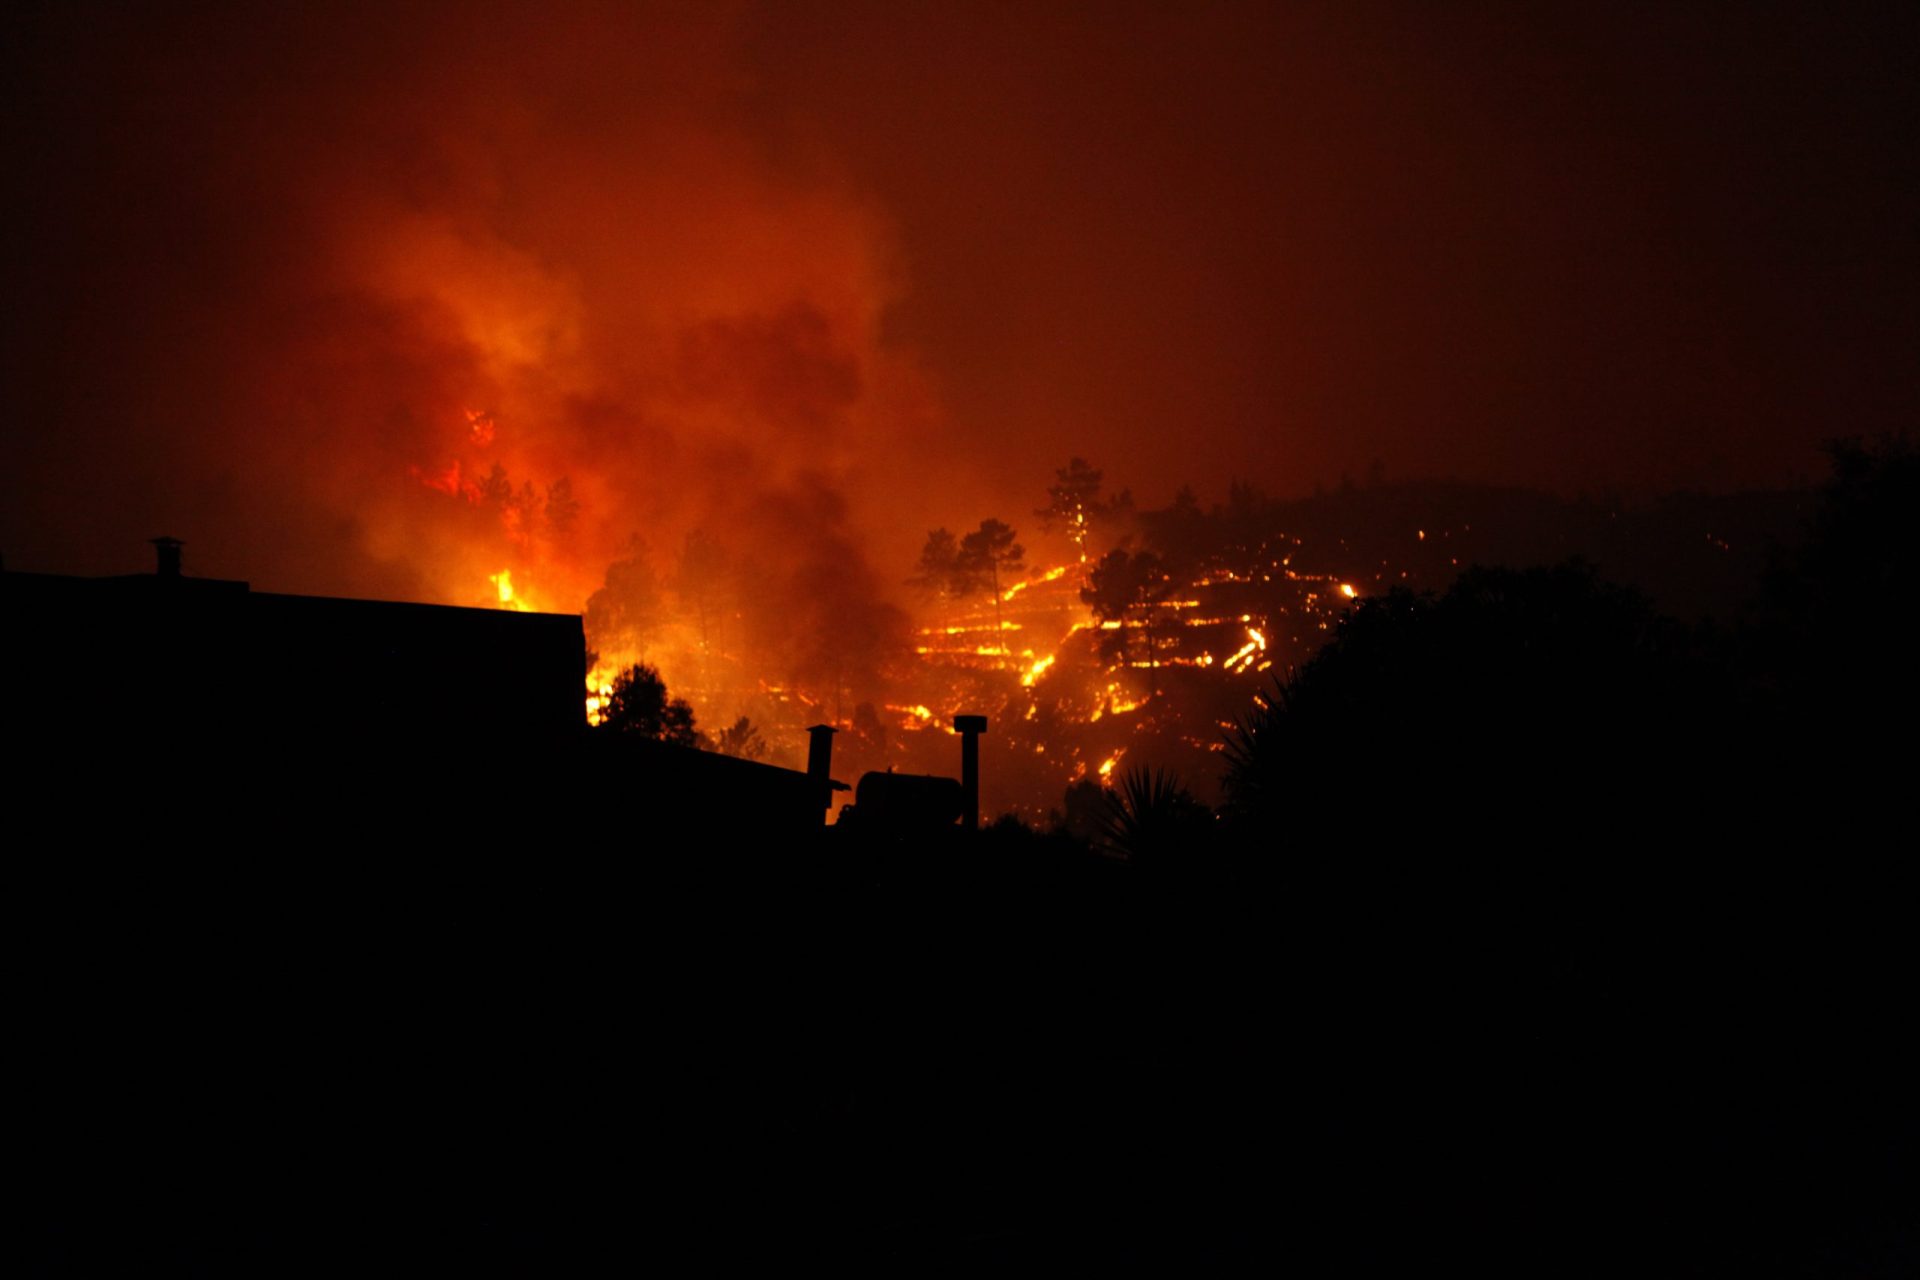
{"left": 374, "top": 360, "right": 1797, "bottom": 819}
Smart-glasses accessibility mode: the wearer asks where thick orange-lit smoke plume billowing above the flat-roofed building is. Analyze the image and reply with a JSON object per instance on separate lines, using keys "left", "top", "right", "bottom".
{"left": 6, "top": 4, "right": 931, "bottom": 710}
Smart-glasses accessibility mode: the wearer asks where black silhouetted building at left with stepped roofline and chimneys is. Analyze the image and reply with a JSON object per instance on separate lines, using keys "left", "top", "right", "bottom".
{"left": 0, "top": 537, "right": 871, "bottom": 854}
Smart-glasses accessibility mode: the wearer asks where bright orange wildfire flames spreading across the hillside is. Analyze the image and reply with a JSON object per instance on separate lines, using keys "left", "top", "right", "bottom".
{"left": 389, "top": 387, "right": 1440, "bottom": 814}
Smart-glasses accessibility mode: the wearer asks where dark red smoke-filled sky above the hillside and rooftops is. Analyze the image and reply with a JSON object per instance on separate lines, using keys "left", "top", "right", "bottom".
{"left": 0, "top": 0, "right": 1920, "bottom": 610}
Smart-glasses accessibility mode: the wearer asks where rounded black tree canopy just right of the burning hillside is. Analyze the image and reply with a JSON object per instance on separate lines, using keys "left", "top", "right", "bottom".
{"left": 1223, "top": 560, "right": 1722, "bottom": 833}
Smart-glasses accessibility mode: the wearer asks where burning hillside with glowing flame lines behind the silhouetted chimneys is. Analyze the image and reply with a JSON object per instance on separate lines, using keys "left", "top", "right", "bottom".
{"left": 397, "top": 409, "right": 1425, "bottom": 818}
